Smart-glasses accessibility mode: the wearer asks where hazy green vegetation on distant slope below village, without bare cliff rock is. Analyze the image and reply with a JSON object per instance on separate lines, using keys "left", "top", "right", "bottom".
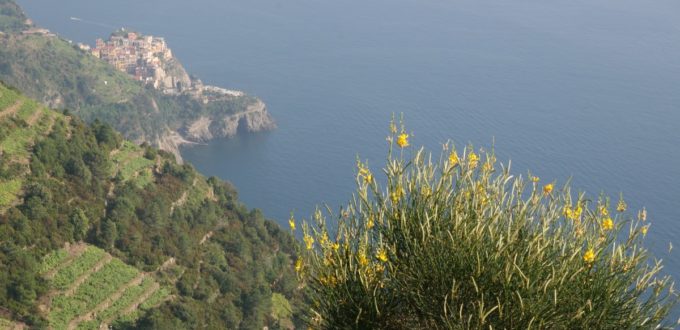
{"left": 0, "top": 0, "right": 256, "bottom": 146}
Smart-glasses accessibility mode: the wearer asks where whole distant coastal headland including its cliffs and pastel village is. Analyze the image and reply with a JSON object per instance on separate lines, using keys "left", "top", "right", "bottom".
{"left": 0, "top": 20, "right": 276, "bottom": 161}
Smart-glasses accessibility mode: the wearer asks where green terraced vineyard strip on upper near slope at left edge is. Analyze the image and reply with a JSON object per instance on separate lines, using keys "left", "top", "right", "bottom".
{"left": 0, "top": 85, "right": 59, "bottom": 212}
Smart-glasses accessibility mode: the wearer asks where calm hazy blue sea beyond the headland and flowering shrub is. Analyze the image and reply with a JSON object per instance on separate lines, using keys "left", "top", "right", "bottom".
{"left": 19, "top": 0, "right": 680, "bottom": 279}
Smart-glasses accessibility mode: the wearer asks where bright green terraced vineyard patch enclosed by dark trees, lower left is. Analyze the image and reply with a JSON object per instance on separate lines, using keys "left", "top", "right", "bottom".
{"left": 42, "top": 244, "right": 170, "bottom": 330}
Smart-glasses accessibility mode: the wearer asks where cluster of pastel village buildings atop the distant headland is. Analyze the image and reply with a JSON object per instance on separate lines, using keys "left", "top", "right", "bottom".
{"left": 87, "top": 29, "right": 244, "bottom": 102}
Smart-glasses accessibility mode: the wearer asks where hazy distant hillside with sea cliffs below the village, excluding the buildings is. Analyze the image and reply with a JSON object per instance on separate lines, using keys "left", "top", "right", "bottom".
{"left": 0, "top": 0, "right": 276, "bottom": 159}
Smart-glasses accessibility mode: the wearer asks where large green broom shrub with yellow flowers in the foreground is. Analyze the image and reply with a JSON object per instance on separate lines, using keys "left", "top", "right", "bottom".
{"left": 291, "top": 123, "right": 677, "bottom": 329}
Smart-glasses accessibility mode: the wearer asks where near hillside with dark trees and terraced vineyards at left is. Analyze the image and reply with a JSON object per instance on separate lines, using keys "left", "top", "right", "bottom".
{"left": 0, "top": 84, "right": 301, "bottom": 329}
